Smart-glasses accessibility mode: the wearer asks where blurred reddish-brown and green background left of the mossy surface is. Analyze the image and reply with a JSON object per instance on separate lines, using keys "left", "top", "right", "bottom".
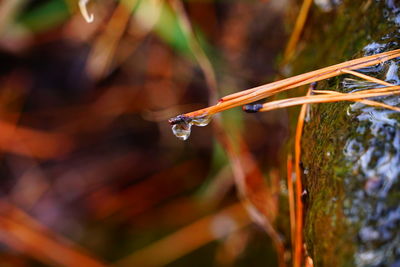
{"left": 0, "top": 0, "right": 308, "bottom": 266}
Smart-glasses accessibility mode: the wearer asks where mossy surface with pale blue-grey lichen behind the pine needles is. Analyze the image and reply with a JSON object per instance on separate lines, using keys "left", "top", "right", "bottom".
{"left": 292, "top": 1, "right": 400, "bottom": 266}
